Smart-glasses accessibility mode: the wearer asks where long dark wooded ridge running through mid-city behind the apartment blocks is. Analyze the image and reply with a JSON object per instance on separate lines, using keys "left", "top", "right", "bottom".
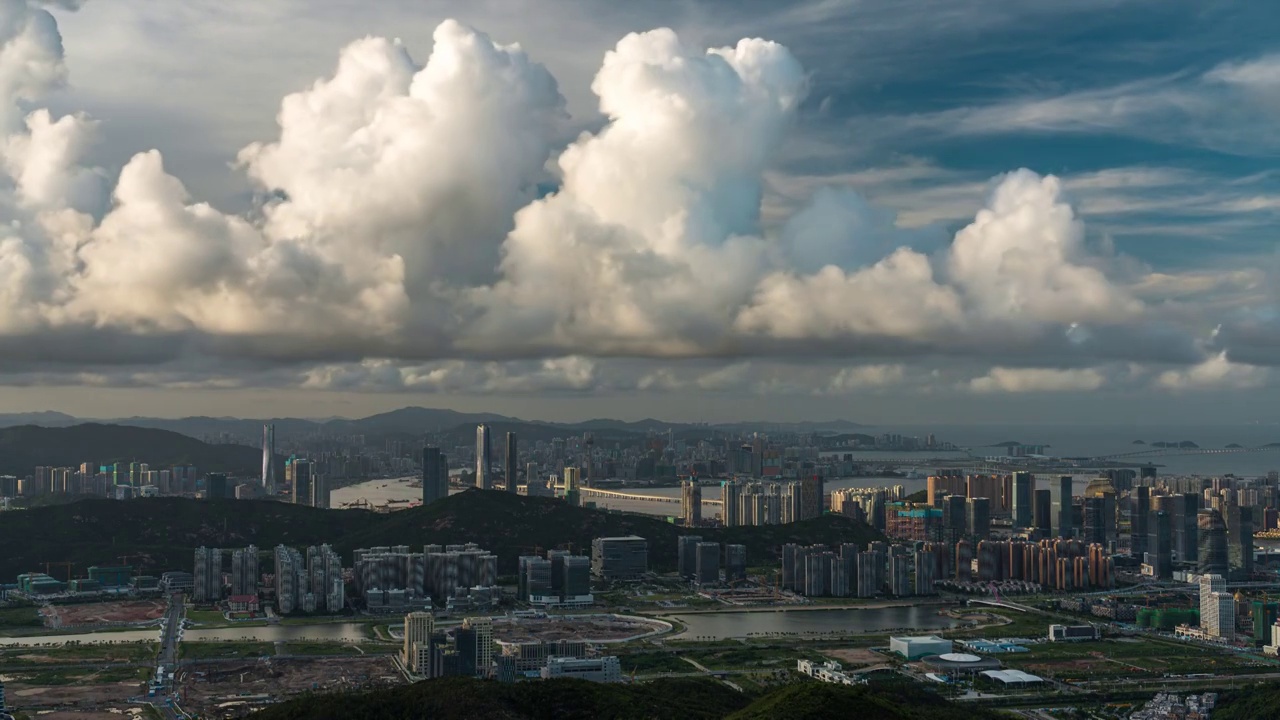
{"left": 0, "top": 491, "right": 882, "bottom": 578}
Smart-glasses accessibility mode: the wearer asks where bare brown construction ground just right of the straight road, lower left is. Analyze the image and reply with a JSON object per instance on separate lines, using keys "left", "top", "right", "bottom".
{"left": 175, "top": 655, "right": 404, "bottom": 717}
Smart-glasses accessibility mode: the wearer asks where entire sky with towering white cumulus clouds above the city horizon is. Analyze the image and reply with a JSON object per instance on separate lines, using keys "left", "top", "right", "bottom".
{"left": 0, "top": 0, "right": 1280, "bottom": 424}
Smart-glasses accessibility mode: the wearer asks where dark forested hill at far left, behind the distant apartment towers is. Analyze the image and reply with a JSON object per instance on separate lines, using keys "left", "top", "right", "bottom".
{"left": 0, "top": 424, "right": 262, "bottom": 478}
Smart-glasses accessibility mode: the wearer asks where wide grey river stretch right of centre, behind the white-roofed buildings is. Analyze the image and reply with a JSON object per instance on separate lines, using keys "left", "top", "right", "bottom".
{"left": 663, "top": 605, "right": 960, "bottom": 639}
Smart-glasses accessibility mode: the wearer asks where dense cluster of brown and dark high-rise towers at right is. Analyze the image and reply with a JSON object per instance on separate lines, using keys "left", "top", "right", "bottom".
{"left": 831, "top": 469, "right": 1259, "bottom": 579}
